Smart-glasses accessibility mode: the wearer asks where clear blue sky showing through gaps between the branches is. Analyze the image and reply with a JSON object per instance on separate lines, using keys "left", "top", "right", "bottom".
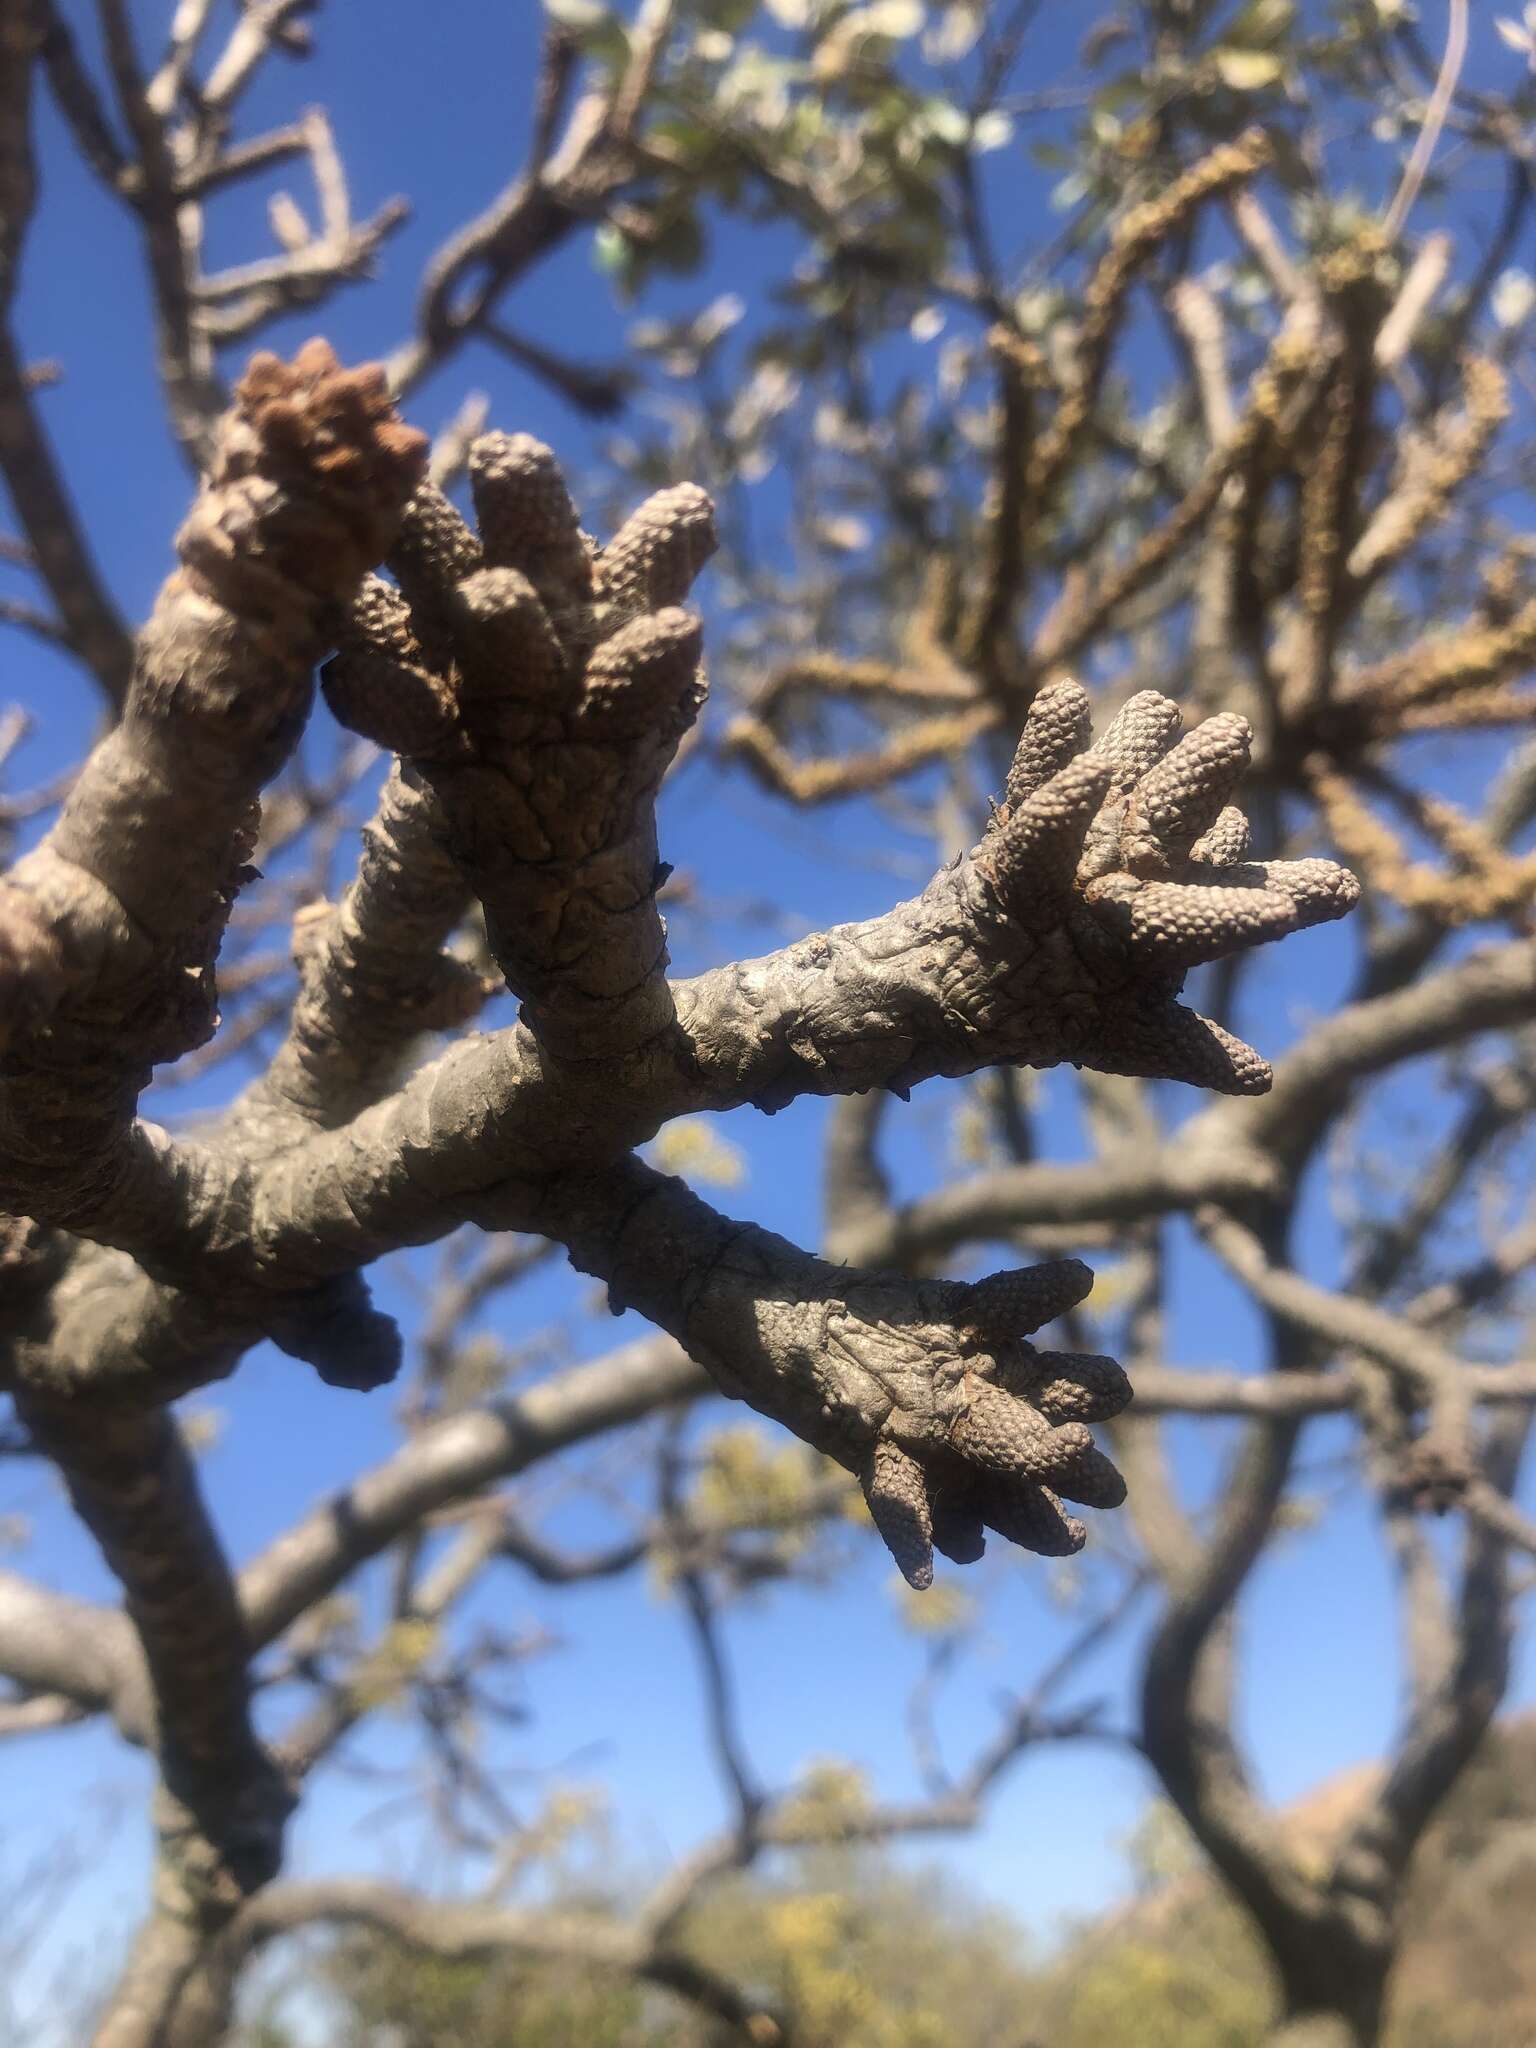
{"left": 0, "top": 0, "right": 1534, "bottom": 2023}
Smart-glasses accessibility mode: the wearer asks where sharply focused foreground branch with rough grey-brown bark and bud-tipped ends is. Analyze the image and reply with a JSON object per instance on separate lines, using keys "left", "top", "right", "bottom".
{"left": 0, "top": 344, "right": 1354, "bottom": 2048}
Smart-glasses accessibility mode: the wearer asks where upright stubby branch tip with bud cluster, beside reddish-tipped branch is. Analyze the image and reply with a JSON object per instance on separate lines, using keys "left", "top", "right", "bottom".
{"left": 324, "top": 434, "right": 715, "bottom": 1059}
